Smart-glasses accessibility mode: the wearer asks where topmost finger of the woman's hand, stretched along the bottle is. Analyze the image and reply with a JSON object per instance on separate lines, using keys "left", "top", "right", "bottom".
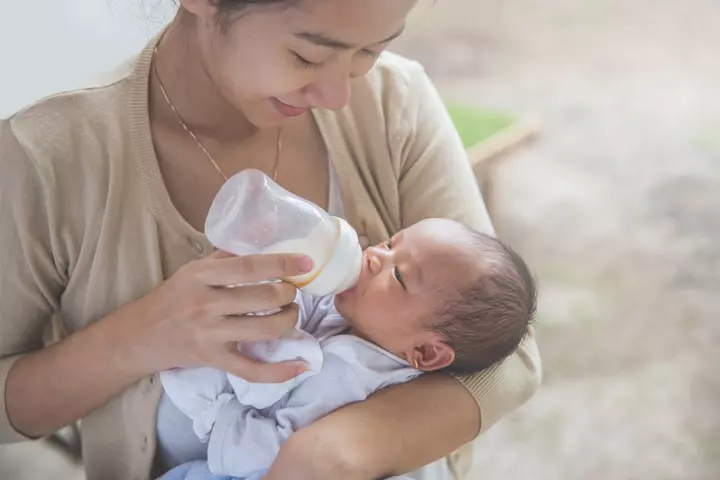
{"left": 195, "top": 252, "right": 313, "bottom": 287}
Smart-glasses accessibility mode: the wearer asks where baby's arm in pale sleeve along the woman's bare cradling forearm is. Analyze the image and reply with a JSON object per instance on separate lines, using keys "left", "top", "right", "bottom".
{"left": 208, "top": 354, "right": 368, "bottom": 478}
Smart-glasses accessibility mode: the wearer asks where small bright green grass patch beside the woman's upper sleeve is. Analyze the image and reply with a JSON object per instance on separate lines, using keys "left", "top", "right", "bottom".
{"left": 446, "top": 102, "right": 517, "bottom": 148}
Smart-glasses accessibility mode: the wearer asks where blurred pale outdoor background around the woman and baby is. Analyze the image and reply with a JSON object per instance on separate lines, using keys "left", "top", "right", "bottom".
{"left": 0, "top": 0, "right": 720, "bottom": 480}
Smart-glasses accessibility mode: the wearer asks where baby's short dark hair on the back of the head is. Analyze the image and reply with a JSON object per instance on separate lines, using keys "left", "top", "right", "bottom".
{"left": 431, "top": 229, "right": 537, "bottom": 373}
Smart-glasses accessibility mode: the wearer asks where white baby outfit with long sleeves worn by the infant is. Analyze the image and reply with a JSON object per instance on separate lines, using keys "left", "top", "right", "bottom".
{"left": 161, "top": 293, "right": 422, "bottom": 478}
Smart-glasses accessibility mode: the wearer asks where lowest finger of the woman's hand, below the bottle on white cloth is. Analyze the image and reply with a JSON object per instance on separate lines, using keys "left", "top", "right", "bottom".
{"left": 217, "top": 351, "right": 307, "bottom": 383}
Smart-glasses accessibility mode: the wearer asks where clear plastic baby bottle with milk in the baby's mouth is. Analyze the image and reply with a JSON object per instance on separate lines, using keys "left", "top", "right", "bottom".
{"left": 205, "top": 169, "right": 362, "bottom": 296}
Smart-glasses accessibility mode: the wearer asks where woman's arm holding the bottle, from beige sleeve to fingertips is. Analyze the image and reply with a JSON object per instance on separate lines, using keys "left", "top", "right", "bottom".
{"left": 0, "top": 121, "right": 309, "bottom": 443}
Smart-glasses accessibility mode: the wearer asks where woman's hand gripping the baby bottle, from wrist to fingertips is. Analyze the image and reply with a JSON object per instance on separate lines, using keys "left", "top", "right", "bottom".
{"left": 123, "top": 251, "right": 312, "bottom": 382}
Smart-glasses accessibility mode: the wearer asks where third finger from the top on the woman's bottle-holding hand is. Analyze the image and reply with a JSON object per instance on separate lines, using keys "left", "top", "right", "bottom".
{"left": 212, "top": 303, "right": 299, "bottom": 342}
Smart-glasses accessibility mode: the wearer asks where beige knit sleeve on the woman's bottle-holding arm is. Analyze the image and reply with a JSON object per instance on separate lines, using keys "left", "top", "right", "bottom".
{"left": 0, "top": 120, "right": 63, "bottom": 444}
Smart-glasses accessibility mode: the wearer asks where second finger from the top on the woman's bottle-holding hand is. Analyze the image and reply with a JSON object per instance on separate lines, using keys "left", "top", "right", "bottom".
{"left": 208, "top": 282, "right": 297, "bottom": 316}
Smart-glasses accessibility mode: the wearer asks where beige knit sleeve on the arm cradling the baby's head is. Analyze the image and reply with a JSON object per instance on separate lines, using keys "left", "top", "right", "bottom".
{"left": 389, "top": 59, "right": 541, "bottom": 432}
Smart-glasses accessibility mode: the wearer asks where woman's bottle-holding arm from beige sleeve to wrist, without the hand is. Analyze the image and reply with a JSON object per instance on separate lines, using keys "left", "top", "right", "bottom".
{"left": 0, "top": 121, "right": 169, "bottom": 443}
